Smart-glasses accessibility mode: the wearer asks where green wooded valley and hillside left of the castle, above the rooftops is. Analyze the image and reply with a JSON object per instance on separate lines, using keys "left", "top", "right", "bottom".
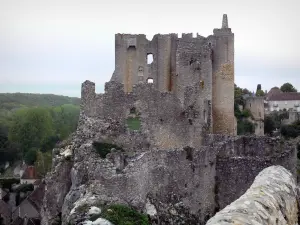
{"left": 0, "top": 93, "right": 80, "bottom": 175}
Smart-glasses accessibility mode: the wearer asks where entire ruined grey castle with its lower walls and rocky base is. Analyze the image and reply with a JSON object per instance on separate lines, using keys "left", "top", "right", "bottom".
{"left": 41, "top": 15, "right": 297, "bottom": 225}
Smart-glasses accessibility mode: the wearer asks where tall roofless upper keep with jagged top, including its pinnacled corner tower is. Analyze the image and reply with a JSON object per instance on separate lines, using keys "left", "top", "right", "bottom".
{"left": 111, "top": 14, "right": 236, "bottom": 135}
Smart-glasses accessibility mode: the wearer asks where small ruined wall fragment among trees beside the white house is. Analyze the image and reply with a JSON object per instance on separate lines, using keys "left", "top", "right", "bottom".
{"left": 245, "top": 97, "right": 265, "bottom": 136}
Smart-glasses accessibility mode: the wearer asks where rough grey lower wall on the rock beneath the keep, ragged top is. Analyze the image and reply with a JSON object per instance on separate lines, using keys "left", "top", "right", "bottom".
{"left": 63, "top": 145, "right": 216, "bottom": 224}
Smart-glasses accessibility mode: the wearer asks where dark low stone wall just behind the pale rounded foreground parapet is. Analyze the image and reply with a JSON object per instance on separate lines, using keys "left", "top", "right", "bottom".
{"left": 215, "top": 137, "right": 297, "bottom": 209}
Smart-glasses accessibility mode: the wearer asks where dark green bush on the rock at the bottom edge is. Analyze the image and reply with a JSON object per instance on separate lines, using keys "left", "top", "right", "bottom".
{"left": 100, "top": 204, "right": 150, "bottom": 225}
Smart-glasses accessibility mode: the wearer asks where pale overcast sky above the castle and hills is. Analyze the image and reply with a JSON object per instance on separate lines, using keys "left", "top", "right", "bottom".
{"left": 0, "top": 0, "right": 300, "bottom": 97}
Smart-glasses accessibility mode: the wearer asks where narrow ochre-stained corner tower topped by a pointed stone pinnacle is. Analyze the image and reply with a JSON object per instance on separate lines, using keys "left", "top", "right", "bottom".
{"left": 212, "top": 14, "right": 236, "bottom": 135}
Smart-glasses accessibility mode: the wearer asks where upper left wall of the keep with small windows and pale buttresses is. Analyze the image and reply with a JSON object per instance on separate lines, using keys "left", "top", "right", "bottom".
{"left": 111, "top": 34, "right": 177, "bottom": 92}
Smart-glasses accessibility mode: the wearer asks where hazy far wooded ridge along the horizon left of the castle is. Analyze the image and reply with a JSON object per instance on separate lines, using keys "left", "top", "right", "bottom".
{"left": 0, "top": 93, "right": 80, "bottom": 128}
